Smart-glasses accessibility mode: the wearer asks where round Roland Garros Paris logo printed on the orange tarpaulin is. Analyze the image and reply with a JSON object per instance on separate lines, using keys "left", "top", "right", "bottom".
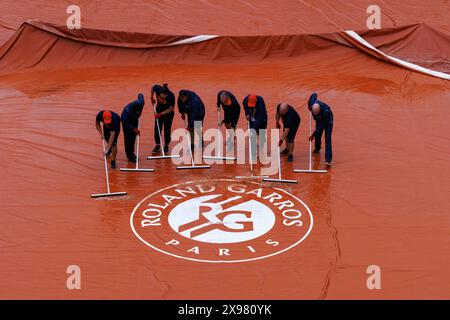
{"left": 130, "top": 179, "right": 313, "bottom": 263}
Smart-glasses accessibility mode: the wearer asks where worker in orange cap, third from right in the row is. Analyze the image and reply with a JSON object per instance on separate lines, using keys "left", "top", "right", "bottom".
{"left": 242, "top": 95, "right": 267, "bottom": 159}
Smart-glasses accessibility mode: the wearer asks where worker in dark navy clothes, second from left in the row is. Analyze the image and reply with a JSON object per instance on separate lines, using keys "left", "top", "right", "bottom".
{"left": 121, "top": 93, "right": 145, "bottom": 163}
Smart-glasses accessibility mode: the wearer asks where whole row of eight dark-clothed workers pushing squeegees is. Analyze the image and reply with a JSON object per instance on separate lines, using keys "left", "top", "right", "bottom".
{"left": 96, "top": 84, "right": 334, "bottom": 168}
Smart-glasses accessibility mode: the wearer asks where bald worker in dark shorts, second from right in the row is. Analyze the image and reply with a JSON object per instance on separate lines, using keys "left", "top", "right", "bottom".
{"left": 276, "top": 103, "right": 301, "bottom": 162}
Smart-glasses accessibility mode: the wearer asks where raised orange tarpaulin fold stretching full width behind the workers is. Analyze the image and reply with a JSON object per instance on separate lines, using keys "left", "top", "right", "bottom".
{"left": 0, "top": 20, "right": 450, "bottom": 79}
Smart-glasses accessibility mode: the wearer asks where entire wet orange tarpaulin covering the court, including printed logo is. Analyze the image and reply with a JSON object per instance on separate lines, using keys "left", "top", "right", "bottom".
{"left": 0, "top": 0, "right": 450, "bottom": 299}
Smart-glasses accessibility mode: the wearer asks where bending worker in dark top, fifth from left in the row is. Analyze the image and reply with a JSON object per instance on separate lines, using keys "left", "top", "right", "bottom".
{"left": 217, "top": 90, "right": 241, "bottom": 148}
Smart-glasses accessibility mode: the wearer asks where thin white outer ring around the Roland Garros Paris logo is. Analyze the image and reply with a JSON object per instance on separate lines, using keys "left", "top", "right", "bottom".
{"left": 130, "top": 179, "right": 314, "bottom": 263}
